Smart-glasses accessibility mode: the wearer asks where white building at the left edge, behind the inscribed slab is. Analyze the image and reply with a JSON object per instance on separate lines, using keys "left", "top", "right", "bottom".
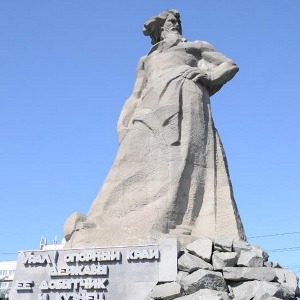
{"left": 0, "top": 260, "right": 17, "bottom": 300}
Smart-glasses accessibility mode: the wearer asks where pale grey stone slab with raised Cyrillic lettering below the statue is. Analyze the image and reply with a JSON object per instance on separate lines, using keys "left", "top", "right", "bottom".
{"left": 10, "top": 239, "right": 178, "bottom": 300}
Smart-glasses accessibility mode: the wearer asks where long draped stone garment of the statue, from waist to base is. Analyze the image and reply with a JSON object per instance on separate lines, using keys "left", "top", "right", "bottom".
{"left": 68, "top": 72, "right": 245, "bottom": 245}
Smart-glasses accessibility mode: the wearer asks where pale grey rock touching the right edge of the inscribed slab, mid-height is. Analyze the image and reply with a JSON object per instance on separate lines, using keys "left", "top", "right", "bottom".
{"left": 178, "top": 253, "right": 213, "bottom": 273}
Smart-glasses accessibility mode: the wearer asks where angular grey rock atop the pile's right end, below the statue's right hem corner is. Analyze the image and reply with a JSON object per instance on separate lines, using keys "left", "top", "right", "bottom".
{"left": 237, "top": 246, "right": 268, "bottom": 267}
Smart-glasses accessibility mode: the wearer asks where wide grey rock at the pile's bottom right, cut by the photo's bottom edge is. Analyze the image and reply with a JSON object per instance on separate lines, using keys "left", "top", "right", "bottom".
{"left": 231, "top": 280, "right": 292, "bottom": 300}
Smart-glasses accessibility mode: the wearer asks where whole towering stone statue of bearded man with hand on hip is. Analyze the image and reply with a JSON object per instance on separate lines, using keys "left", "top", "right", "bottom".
{"left": 65, "top": 10, "right": 245, "bottom": 247}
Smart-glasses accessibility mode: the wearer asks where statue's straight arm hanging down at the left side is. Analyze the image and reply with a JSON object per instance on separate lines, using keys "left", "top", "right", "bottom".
{"left": 117, "top": 57, "right": 145, "bottom": 144}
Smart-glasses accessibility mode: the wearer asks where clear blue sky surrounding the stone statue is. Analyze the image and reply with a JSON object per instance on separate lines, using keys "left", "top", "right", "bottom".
{"left": 0, "top": 0, "right": 300, "bottom": 271}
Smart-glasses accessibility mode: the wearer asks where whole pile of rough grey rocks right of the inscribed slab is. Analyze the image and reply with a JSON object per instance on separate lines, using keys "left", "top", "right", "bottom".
{"left": 145, "top": 239, "right": 299, "bottom": 300}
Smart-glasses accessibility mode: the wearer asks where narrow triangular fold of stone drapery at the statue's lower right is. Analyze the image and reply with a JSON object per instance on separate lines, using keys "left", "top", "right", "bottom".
{"left": 192, "top": 126, "right": 246, "bottom": 240}
